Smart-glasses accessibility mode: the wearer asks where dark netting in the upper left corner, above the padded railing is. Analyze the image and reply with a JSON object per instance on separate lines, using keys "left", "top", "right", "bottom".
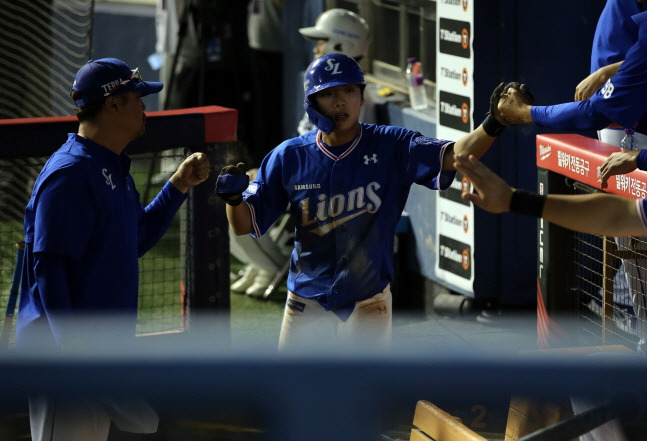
{"left": 0, "top": 0, "right": 94, "bottom": 118}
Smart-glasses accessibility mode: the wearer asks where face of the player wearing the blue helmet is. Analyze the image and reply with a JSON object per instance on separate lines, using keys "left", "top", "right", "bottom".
{"left": 315, "top": 84, "right": 364, "bottom": 132}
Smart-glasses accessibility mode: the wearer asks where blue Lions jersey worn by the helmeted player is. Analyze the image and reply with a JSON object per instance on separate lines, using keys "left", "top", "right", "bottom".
{"left": 243, "top": 123, "right": 455, "bottom": 310}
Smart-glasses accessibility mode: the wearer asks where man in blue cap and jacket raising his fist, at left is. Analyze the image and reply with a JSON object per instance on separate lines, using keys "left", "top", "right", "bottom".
{"left": 16, "top": 58, "right": 209, "bottom": 441}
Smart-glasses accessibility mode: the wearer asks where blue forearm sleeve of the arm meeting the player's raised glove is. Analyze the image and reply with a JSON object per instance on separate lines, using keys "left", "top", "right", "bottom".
{"left": 530, "top": 100, "right": 612, "bottom": 130}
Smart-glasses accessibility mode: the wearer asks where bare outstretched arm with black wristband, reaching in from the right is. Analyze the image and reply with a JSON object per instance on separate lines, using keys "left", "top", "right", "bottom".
{"left": 455, "top": 155, "right": 647, "bottom": 236}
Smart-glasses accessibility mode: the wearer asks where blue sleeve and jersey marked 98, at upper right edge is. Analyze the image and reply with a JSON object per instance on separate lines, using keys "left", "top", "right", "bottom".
{"left": 530, "top": 12, "right": 647, "bottom": 130}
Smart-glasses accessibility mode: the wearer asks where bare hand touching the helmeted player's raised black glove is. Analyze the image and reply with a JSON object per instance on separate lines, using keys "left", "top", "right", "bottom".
{"left": 490, "top": 82, "right": 535, "bottom": 126}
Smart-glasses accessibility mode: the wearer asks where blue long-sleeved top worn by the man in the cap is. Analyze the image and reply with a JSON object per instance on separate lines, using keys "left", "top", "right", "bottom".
{"left": 16, "top": 134, "right": 186, "bottom": 345}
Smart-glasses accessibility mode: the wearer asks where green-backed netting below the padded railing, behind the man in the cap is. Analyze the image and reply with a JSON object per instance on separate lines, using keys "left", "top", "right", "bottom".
{"left": 0, "top": 149, "right": 189, "bottom": 341}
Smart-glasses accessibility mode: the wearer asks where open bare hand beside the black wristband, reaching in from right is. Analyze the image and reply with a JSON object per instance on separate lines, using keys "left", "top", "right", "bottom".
{"left": 454, "top": 154, "right": 513, "bottom": 213}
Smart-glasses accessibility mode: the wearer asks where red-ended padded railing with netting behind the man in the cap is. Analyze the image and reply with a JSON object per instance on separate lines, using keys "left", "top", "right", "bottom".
{"left": 0, "top": 106, "right": 239, "bottom": 341}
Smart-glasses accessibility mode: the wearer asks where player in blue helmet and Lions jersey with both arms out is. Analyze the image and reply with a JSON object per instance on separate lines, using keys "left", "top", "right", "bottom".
{"left": 216, "top": 53, "right": 520, "bottom": 350}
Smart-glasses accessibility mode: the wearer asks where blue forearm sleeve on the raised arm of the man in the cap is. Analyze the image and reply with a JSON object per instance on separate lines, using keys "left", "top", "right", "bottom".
{"left": 137, "top": 181, "right": 187, "bottom": 257}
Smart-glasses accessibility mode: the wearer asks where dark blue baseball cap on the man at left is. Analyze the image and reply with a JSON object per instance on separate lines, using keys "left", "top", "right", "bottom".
{"left": 72, "top": 58, "right": 164, "bottom": 107}
